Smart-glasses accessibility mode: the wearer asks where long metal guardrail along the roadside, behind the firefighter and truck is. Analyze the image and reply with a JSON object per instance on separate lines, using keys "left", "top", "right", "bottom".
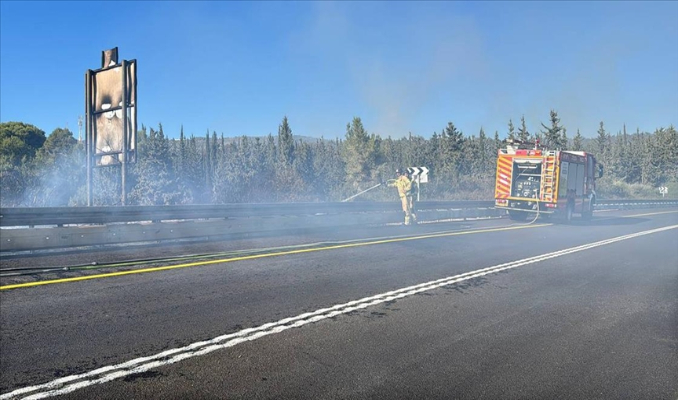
{"left": 0, "top": 200, "right": 678, "bottom": 253}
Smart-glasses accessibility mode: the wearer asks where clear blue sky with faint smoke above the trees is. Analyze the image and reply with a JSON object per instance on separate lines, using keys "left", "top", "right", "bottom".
{"left": 0, "top": 1, "right": 678, "bottom": 138}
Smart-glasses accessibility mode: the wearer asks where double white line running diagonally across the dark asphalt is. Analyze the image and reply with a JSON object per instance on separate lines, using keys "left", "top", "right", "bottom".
{"left": 0, "top": 225, "right": 678, "bottom": 400}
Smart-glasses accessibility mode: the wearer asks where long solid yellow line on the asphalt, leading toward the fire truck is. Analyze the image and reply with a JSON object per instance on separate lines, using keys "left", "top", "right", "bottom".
{"left": 0, "top": 224, "right": 553, "bottom": 290}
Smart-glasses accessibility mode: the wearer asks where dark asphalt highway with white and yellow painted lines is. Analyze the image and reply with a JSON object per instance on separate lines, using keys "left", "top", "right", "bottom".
{"left": 0, "top": 209, "right": 678, "bottom": 400}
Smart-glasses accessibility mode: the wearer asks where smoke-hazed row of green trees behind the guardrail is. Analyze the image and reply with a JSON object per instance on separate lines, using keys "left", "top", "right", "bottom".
{"left": 0, "top": 110, "right": 678, "bottom": 207}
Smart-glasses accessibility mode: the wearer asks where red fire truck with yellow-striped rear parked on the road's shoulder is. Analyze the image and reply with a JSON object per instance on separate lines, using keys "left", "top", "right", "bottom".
{"left": 494, "top": 141, "right": 603, "bottom": 222}
